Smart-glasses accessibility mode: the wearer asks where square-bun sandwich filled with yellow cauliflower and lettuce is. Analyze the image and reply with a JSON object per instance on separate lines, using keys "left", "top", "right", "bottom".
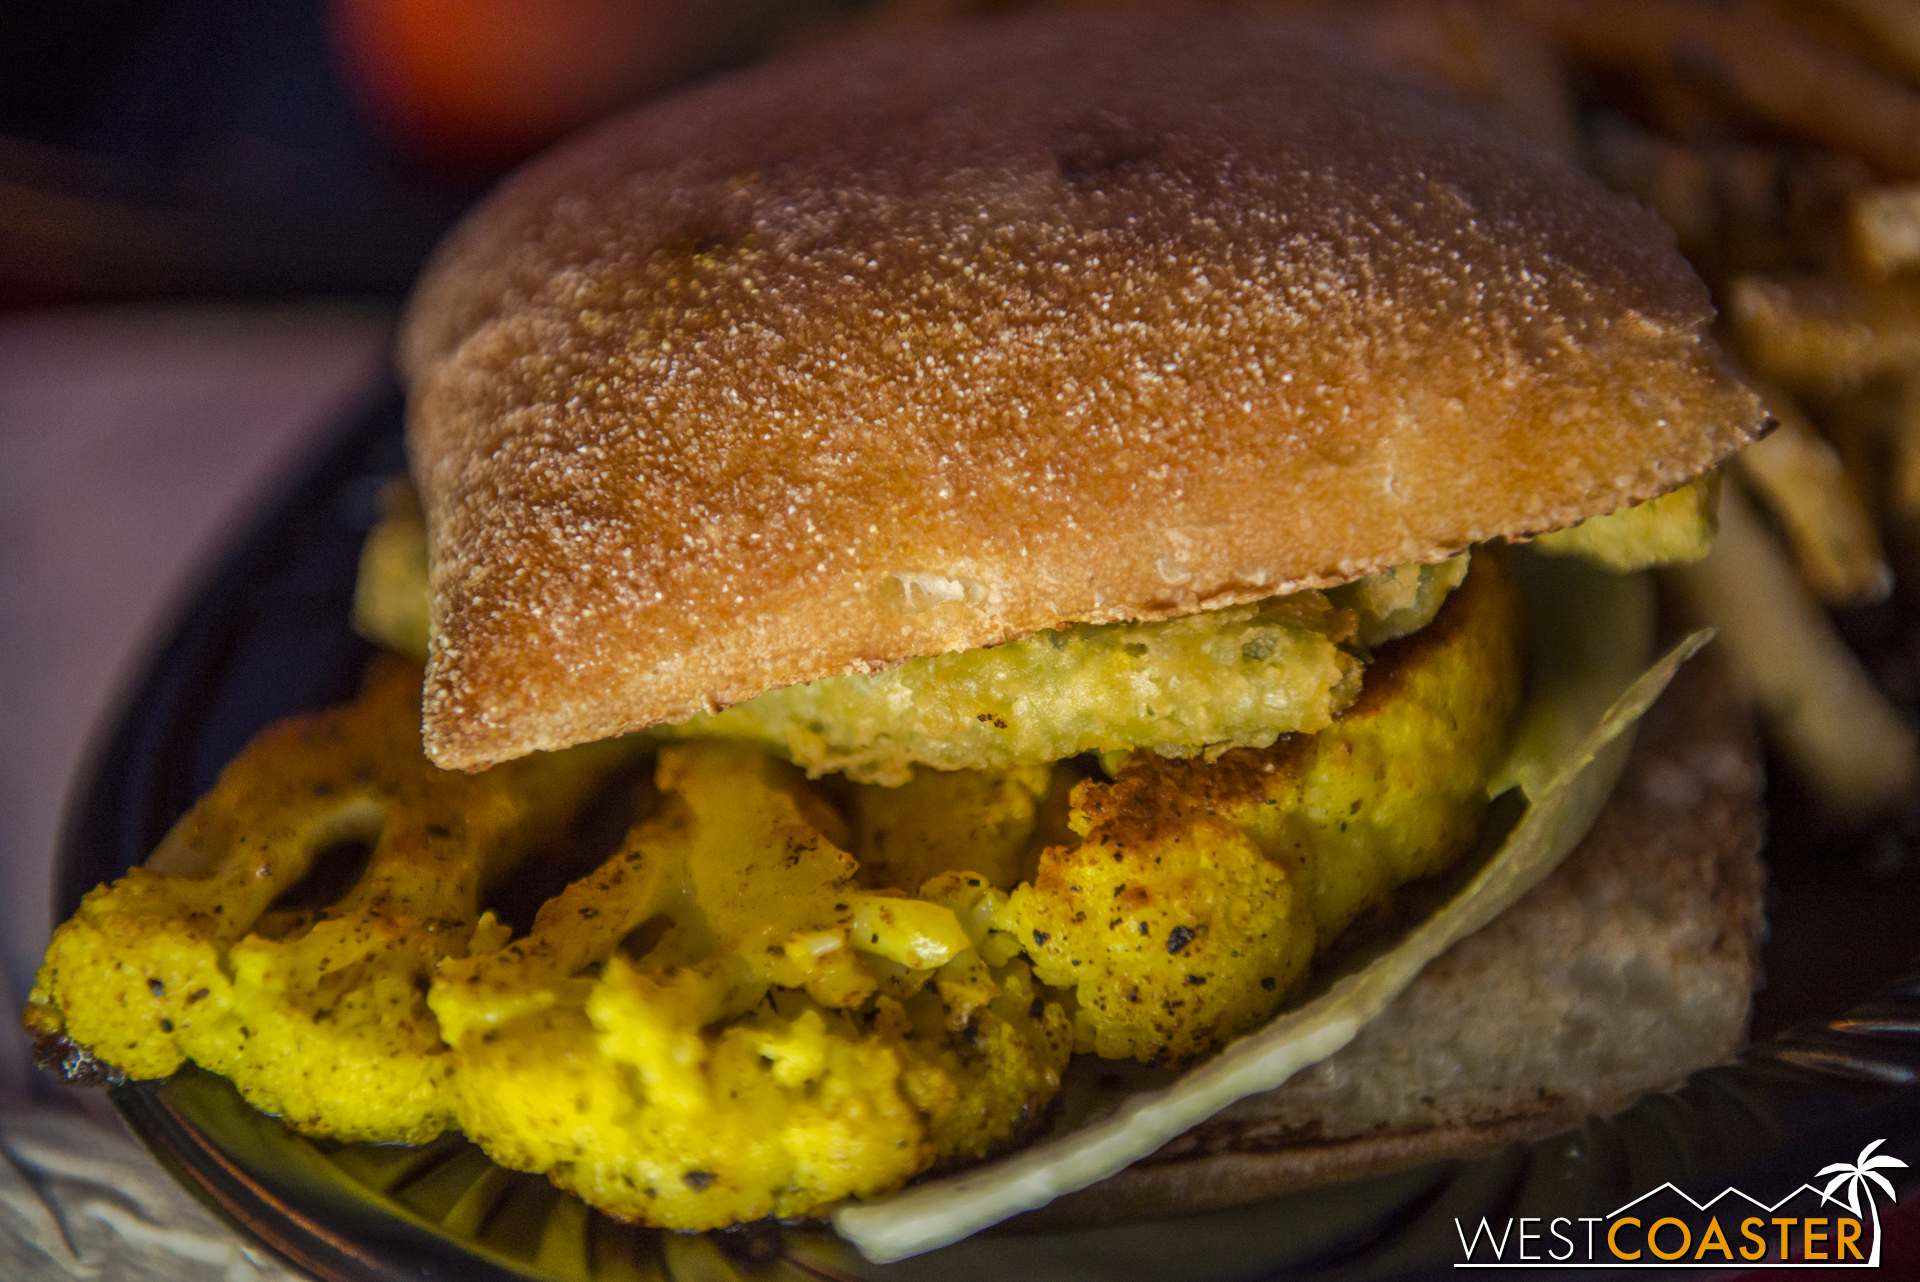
{"left": 27, "top": 10, "right": 1764, "bottom": 1257}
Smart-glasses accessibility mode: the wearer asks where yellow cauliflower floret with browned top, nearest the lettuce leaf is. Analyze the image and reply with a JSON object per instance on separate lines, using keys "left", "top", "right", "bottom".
{"left": 991, "top": 555, "right": 1523, "bottom": 1061}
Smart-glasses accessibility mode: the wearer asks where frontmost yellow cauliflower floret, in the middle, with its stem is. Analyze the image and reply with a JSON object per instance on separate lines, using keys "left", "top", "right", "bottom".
{"left": 430, "top": 743, "right": 1071, "bottom": 1228}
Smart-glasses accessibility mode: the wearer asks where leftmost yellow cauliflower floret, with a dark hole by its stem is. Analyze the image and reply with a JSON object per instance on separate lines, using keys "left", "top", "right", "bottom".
{"left": 27, "top": 662, "right": 632, "bottom": 1142}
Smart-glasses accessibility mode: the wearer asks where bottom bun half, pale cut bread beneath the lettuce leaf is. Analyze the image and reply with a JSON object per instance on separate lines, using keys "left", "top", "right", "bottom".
{"left": 1018, "top": 651, "right": 1764, "bottom": 1228}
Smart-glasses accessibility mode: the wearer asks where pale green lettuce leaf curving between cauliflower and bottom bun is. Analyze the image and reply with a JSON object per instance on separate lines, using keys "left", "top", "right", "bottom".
{"left": 833, "top": 555, "right": 1711, "bottom": 1263}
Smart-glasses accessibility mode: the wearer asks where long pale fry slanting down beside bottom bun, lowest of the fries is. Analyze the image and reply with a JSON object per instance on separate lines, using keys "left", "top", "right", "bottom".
{"left": 1665, "top": 486, "right": 1920, "bottom": 816}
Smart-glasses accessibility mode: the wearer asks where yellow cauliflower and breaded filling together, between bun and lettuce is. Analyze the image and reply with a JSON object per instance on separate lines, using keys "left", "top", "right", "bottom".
{"left": 27, "top": 477, "right": 1712, "bottom": 1228}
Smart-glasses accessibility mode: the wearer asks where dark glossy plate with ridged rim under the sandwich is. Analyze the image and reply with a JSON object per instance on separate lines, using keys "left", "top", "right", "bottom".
{"left": 56, "top": 390, "right": 1920, "bottom": 1282}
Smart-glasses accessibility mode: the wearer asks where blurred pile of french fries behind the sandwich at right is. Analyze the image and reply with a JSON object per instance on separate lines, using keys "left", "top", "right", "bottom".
{"left": 817, "top": 0, "right": 1920, "bottom": 819}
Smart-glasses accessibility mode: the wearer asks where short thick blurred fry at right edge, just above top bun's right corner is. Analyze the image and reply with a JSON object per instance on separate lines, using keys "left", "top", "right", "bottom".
{"left": 1726, "top": 274, "right": 1920, "bottom": 392}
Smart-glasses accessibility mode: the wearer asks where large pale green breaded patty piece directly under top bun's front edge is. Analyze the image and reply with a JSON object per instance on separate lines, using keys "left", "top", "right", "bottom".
{"left": 660, "top": 557, "right": 1467, "bottom": 785}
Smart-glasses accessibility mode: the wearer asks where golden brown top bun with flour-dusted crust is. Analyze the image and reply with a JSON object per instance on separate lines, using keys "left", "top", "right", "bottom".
{"left": 401, "top": 10, "right": 1761, "bottom": 768}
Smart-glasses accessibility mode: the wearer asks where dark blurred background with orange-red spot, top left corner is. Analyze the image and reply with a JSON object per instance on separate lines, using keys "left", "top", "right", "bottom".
{"left": 0, "top": 0, "right": 879, "bottom": 307}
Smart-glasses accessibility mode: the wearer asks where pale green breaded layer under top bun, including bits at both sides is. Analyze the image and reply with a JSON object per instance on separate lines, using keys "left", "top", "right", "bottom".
{"left": 355, "top": 474, "right": 1718, "bottom": 787}
